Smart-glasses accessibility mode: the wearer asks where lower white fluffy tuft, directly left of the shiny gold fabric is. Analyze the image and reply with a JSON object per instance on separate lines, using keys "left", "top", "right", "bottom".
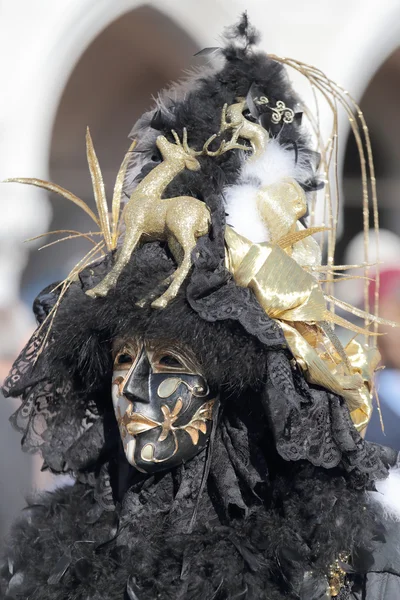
{"left": 224, "top": 183, "right": 270, "bottom": 243}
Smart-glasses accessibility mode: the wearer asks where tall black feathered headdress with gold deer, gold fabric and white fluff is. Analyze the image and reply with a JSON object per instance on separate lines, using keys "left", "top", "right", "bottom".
{"left": 5, "top": 15, "right": 388, "bottom": 474}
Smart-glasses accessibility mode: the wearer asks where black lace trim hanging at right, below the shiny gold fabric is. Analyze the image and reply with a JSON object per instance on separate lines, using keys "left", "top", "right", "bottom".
{"left": 263, "top": 351, "right": 395, "bottom": 487}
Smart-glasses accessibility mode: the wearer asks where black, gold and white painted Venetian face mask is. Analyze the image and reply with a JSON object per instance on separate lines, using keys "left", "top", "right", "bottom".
{"left": 112, "top": 339, "right": 218, "bottom": 473}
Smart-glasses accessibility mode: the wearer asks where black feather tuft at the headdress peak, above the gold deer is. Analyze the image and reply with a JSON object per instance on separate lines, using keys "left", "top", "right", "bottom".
{"left": 125, "top": 15, "right": 313, "bottom": 196}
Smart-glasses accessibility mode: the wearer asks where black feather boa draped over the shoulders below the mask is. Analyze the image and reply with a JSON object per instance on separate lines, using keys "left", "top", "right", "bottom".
{"left": 3, "top": 398, "right": 394, "bottom": 600}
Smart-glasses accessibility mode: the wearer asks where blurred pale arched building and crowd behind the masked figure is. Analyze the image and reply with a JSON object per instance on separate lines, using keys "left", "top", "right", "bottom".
{"left": 0, "top": 0, "right": 400, "bottom": 537}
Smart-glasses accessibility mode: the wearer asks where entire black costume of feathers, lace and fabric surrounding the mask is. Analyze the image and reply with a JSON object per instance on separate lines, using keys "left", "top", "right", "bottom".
{"left": 1, "top": 16, "right": 400, "bottom": 600}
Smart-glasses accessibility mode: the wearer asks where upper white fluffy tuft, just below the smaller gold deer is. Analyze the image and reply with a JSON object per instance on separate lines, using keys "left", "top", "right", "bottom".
{"left": 241, "top": 138, "right": 311, "bottom": 185}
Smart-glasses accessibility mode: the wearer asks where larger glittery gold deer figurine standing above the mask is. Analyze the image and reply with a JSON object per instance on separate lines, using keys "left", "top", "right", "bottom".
{"left": 86, "top": 129, "right": 215, "bottom": 308}
